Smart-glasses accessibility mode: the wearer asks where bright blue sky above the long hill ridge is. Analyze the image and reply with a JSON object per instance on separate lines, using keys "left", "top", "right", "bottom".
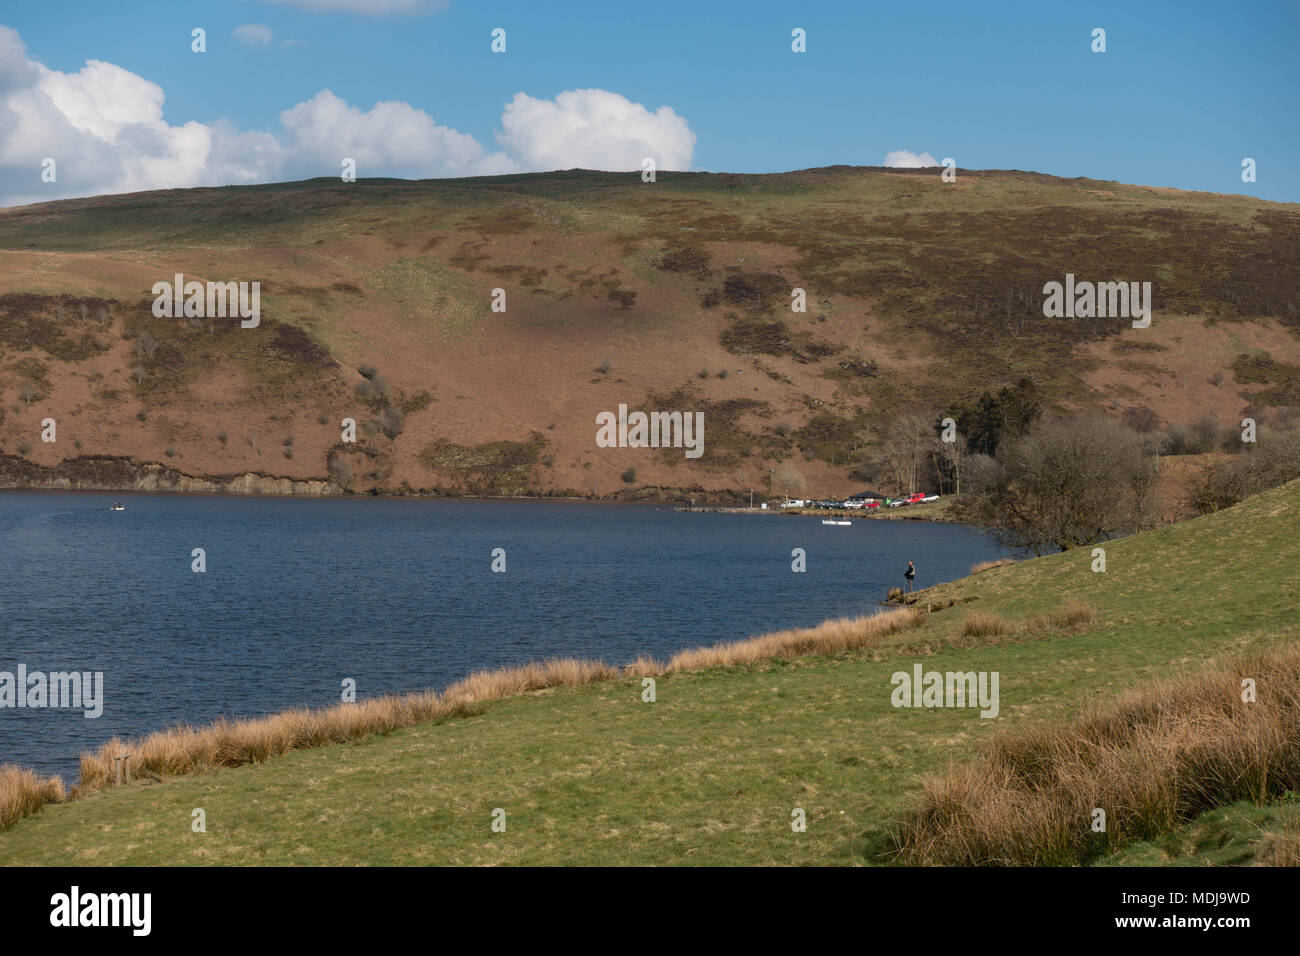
{"left": 0, "top": 0, "right": 1300, "bottom": 202}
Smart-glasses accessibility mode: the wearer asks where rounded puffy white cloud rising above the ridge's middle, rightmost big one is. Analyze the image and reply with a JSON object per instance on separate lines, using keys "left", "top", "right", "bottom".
{"left": 498, "top": 90, "right": 696, "bottom": 169}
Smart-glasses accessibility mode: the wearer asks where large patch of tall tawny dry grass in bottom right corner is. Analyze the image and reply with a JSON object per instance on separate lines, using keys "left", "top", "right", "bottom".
{"left": 894, "top": 648, "right": 1300, "bottom": 866}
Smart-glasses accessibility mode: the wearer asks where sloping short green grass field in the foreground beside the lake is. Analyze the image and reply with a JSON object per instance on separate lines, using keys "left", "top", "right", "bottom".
{"left": 0, "top": 483, "right": 1300, "bottom": 865}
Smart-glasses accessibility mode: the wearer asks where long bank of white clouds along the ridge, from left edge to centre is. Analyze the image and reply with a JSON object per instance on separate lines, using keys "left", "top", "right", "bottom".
{"left": 0, "top": 26, "right": 696, "bottom": 206}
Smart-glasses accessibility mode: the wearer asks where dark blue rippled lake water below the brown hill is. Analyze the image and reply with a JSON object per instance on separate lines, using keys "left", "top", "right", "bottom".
{"left": 0, "top": 493, "right": 1002, "bottom": 782}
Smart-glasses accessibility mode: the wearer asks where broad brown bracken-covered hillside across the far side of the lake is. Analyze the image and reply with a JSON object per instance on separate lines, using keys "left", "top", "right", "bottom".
{"left": 0, "top": 166, "right": 1300, "bottom": 497}
